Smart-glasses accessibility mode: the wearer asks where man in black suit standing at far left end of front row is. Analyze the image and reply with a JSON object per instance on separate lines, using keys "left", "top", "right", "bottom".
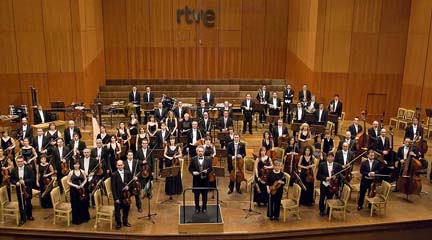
{"left": 10, "top": 156, "right": 35, "bottom": 226}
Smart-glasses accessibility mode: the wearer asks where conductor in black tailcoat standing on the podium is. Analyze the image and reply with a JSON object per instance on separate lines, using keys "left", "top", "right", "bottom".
{"left": 189, "top": 146, "right": 212, "bottom": 213}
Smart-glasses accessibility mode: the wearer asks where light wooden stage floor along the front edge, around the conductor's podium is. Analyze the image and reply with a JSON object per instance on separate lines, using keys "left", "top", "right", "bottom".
{"left": 0, "top": 174, "right": 432, "bottom": 240}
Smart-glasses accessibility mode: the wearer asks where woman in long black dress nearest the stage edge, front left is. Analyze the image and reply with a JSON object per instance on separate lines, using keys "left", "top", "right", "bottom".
{"left": 67, "top": 161, "right": 90, "bottom": 224}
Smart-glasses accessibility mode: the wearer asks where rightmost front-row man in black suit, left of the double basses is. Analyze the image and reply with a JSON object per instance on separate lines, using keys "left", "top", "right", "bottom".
{"left": 357, "top": 149, "right": 379, "bottom": 211}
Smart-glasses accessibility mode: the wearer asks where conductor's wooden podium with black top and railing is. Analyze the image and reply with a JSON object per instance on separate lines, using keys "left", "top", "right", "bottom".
{"left": 178, "top": 188, "right": 224, "bottom": 233}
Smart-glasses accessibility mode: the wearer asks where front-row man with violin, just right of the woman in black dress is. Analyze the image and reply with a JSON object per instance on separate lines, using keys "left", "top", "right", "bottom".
{"left": 316, "top": 152, "right": 342, "bottom": 216}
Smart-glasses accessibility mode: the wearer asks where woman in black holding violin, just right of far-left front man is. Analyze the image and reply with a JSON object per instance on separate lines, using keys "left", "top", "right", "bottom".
{"left": 36, "top": 154, "right": 55, "bottom": 208}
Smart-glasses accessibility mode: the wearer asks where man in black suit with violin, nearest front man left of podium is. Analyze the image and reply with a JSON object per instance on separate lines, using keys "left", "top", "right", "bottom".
{"left": 111, "top": 160, "right": 132, "bottom": 229}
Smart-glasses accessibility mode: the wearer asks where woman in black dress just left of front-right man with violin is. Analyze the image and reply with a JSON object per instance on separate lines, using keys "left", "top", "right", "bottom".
{"left": 298, "top": 146, "right": 315, "bottom": 206}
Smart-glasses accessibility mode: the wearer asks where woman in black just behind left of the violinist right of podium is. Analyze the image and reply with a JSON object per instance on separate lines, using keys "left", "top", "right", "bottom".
{"left": 253, "top": 147, "right": 273, "bottom": 207}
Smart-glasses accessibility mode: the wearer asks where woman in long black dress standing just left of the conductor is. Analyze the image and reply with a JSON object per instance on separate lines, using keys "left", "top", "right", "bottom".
{"left": 164, "top": 136, "right": 183, "bottom": 196}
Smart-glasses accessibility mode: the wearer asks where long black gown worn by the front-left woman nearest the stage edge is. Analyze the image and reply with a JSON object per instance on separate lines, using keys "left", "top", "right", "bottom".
{"left": 70, "top": 170, "right": 90, "bottom": 224}
